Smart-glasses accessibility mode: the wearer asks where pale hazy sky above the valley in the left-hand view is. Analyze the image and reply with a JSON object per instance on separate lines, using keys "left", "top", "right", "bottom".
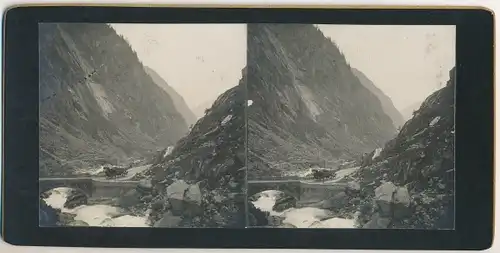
{"left": 112, "top": 24, "right": 247, "bottom": 109}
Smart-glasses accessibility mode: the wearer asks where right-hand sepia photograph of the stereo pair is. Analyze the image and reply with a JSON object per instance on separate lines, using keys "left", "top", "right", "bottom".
{"left": 247, "top": 24, "right": 455, "bottom": 229}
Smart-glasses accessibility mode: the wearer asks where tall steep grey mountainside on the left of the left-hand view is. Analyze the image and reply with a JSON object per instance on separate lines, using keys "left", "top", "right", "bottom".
{"left": 39, "top": 24, "right": 187, "bottom": 176}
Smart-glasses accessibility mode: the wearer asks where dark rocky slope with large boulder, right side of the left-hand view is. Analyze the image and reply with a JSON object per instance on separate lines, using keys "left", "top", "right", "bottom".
{"left": 144, "top": 70, "right": 246, "bottom": 228}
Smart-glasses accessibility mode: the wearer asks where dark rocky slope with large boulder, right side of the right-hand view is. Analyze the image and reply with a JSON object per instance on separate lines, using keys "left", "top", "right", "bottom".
{"left": 346, "top": 66, "right": 455, "bottom": 229}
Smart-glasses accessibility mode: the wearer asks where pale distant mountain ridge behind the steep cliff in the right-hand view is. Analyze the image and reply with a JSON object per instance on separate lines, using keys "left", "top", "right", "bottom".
{"left": 352, "top": 68, "right": 405, "bottom": 127}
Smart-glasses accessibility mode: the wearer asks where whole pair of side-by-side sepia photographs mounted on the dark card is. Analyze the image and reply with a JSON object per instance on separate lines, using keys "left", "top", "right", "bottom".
{"left": 39, "top": 23, "right": 456, "bottom": 229}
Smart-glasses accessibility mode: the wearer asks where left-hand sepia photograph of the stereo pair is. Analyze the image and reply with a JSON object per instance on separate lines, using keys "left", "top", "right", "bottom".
{"left": 39, "top": 23, "right": 247, "bottom": 228}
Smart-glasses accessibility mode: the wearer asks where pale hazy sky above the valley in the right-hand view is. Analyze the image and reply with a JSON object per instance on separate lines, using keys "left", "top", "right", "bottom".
{"left": 319, "top": 25, "right": 456, "bottom": 111}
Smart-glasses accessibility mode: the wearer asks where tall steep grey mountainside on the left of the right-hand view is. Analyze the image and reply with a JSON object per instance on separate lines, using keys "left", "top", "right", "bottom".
{"left": 247, "top": 24, "right": 396, "bottom": 177}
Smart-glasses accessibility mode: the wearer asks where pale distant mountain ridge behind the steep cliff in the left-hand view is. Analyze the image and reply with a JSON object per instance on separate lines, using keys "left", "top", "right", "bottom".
{"left": 145, "top": 66, "right": 196, "bottom": 125}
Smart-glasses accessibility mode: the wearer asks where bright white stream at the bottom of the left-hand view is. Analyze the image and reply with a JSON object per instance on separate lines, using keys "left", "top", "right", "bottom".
{"left": 45, "top": 187, "right": 148, "bottom": 227}
